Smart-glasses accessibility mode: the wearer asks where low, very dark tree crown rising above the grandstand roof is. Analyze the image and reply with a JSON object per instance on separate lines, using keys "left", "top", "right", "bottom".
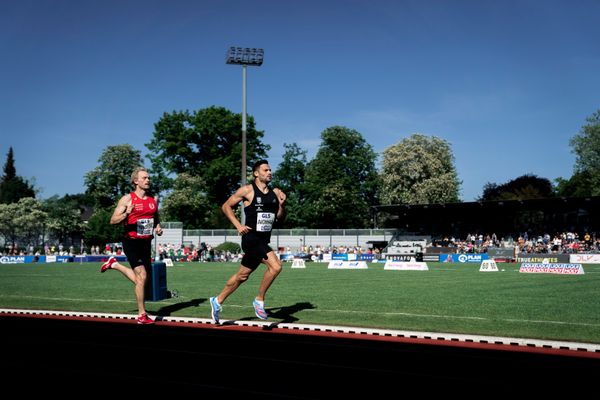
{"left": 478, "top": 174, "right": 554, "bottom": 201}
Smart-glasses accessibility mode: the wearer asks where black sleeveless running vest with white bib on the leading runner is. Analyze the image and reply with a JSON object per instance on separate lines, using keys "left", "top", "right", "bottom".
{"left": 244, "top": 182, "right": 279, "bottom": 242}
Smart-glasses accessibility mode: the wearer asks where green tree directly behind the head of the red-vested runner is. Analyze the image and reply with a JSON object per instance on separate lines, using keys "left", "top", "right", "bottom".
{"left": 85, "top": 144, "right": 144, "bottom": 207}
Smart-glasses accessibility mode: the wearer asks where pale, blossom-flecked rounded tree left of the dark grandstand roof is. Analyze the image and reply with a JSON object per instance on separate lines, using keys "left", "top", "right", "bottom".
{"left": 380, "top": 134, "right": 461, "bottom": 204}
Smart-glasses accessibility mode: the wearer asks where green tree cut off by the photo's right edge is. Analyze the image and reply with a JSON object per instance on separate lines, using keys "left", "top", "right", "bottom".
{"left": 557, "top": 110, "right": 600, "bottom": 197}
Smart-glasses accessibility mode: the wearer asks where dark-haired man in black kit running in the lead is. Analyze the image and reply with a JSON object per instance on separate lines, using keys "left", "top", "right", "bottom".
{"left": 210, "top": 160, "right": 286, "bottom": 323}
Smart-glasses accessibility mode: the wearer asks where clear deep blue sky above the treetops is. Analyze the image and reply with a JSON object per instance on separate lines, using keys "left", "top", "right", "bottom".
{"left": 0, "top": 0, "right": 600, "bottom": 201}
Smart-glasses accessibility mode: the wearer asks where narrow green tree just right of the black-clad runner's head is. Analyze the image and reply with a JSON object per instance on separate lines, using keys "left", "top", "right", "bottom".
{"left": 272, "top": 143, "right": 306, "bottom": 228}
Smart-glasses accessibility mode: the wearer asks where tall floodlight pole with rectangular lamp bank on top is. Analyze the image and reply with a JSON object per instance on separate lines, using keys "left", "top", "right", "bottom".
{"left": 225, "top": 46, "right": 265, "bottom": 225}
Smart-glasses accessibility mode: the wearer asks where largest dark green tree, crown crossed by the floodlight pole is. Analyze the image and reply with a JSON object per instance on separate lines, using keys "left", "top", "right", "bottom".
{"left": 146, "top": 106, "right": 270, "bottom": 208}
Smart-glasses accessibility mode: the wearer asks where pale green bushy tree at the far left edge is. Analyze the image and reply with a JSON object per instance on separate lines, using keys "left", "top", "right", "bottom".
{"left": 0, "top": 197, "right": 48, "bottom": 246}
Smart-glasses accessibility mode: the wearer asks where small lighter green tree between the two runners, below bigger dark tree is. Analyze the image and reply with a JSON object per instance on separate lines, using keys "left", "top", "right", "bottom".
{"left": 161, "top": 172, "right": 211, "bottom": 229}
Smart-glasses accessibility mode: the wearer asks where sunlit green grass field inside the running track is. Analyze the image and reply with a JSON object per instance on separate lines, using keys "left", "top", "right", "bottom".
{"left": 0, "top": 263, "right": 600, "bottom": 343}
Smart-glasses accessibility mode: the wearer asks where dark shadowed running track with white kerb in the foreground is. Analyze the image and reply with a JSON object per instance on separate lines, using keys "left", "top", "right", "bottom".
{"left": 0, "top": 310, "right": 600, "bottom": 399}
